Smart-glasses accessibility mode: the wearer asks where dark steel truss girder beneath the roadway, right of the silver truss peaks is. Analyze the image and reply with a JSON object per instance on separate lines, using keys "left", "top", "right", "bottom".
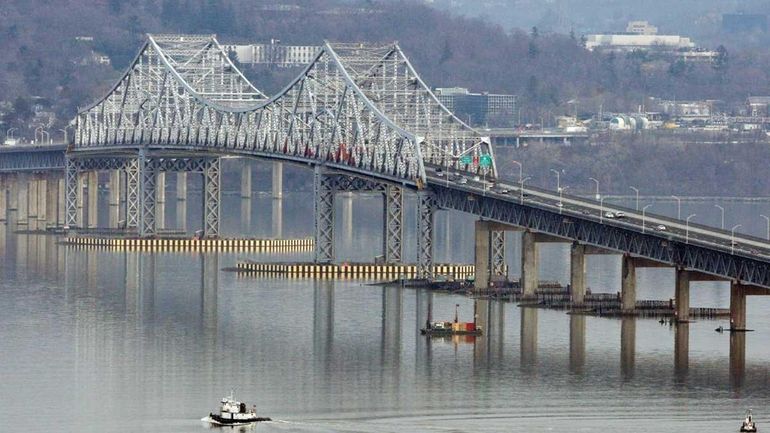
{"left": 431, "top": 184, "right": 770, "bottom": 288}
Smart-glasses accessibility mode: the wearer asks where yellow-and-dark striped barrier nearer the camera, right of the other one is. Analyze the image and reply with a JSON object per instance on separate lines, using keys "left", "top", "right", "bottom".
{"left": 235, "top": 262, "right": 476, "bottom": 280}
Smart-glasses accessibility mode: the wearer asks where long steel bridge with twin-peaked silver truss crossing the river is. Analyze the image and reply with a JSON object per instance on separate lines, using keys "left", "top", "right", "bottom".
{"left": 0, "top": 35, "right": 770, "bottom": 340}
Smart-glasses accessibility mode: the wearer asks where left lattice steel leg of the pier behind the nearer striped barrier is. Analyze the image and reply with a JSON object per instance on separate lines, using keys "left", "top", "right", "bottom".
{"left": 313, "top": 166, "right": 336, "bottom": 263}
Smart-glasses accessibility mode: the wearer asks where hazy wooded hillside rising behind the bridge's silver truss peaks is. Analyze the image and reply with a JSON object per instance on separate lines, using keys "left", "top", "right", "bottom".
{"left": 0, "top": 0, "right": 770, "bottom": 133}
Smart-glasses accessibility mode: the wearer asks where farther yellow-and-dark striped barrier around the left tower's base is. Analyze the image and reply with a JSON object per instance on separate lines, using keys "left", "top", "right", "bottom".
{"left": 61, "top": 236, "right": 314, "bottom": 253}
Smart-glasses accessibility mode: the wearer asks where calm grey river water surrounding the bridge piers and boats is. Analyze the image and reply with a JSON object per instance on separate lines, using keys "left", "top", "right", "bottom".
{"left": 0, "top": 186, "right": 770, "bottom": 433}
